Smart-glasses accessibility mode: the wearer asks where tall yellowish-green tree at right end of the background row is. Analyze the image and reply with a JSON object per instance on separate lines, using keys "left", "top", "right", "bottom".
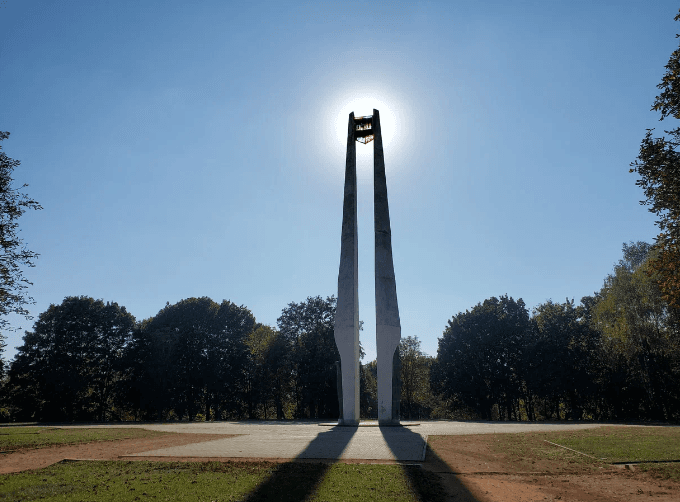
{"left": 593, "top": 242, "right": 679, "bottom": 419}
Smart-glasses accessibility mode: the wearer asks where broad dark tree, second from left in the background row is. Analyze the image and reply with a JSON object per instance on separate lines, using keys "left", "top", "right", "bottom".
{"left": 130, "top": 297, "right": 255, "bottom": 420}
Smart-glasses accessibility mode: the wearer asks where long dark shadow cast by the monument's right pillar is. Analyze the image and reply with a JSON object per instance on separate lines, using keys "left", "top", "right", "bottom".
{"left": 380, "top": 425, "right": 480, "bottom": 502}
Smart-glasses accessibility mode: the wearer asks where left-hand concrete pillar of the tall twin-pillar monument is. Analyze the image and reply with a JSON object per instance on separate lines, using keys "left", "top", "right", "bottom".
{"left": 334, "top": 113, "right": 359, "bottom": 425}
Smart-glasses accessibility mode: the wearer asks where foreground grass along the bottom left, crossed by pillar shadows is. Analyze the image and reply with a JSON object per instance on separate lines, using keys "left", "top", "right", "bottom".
{"left": 0, "top": 461, "right": 441, "bottom": 502}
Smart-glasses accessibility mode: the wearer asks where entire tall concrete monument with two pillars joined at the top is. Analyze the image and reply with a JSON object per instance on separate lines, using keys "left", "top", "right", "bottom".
{"left": 335, "top": 109, "right": 401, "bottom": 425}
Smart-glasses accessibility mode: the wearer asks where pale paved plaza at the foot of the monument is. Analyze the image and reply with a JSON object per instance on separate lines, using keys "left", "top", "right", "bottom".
{"left": 69, "top": 421, "right": 599, "bottom": 462}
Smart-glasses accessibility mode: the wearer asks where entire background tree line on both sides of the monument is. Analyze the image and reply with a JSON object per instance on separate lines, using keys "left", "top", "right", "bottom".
{"left": 0, "top": 242, "right": 680, "bottom": 421}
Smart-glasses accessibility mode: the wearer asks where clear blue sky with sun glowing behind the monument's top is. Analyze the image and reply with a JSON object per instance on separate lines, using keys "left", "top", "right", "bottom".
{"left": 0, "top": 0, "right": 680, "bottom": 360}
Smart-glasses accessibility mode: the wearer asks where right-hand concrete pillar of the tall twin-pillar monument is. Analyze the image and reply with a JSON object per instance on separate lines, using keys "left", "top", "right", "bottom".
{"left": 372, "top": 109, "right": 401, "bottom": 424}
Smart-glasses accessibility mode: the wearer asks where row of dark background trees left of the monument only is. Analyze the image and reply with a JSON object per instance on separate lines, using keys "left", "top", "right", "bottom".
{"left": 2, "top": 296, "right": 348, "bottom": 421}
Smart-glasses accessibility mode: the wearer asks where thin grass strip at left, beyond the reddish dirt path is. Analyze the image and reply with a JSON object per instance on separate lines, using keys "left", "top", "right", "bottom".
{"left": 0, "top": 427, "right": 168, "bottom": 452}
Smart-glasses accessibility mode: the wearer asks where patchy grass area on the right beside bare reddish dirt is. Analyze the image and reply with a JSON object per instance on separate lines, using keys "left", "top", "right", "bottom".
{"left": 493, "top": 426, "right": 680, "bottom": 481}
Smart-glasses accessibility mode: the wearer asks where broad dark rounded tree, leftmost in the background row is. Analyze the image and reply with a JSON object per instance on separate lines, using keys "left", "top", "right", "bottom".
{"left": 9, "top": 296, "right": 135, "bottom": 420}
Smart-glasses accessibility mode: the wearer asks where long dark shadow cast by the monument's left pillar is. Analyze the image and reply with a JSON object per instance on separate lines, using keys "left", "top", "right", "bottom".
{"left": 243, "top": 426, "right": 357, "bottom": 502}
